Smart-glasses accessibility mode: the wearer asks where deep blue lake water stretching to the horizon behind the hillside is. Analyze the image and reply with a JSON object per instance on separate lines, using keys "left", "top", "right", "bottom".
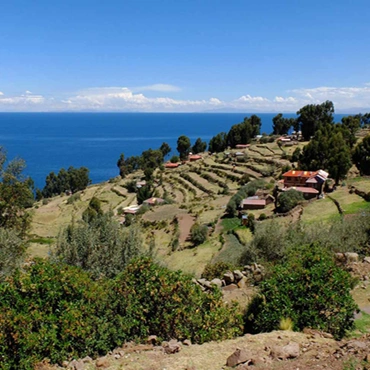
{"left": 0, "top": 113, "right": 343, "bottom": 188}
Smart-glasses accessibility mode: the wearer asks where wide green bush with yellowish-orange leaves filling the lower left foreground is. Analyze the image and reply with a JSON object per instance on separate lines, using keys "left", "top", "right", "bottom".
{"left": 0, "top": 258, "right": 242, "bottom": 370}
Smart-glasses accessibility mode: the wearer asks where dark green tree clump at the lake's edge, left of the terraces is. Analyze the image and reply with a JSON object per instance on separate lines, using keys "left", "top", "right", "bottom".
{"left": 42, "top": 166, "right": 91, "bottom": 198}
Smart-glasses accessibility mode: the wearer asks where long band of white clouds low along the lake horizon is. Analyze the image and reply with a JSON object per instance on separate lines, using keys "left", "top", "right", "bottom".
{"left": 0, "top": 84, "right": 370, "bottom": 112}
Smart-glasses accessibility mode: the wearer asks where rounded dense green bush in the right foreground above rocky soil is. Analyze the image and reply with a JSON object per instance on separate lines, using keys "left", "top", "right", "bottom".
{"left": 246, "top": 244, "right": 358, "bottom": 339}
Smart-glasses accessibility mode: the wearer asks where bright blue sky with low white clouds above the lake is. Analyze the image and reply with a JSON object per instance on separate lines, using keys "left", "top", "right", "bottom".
{"left": 0, "top": 0, "right": 370, "bottom": 113}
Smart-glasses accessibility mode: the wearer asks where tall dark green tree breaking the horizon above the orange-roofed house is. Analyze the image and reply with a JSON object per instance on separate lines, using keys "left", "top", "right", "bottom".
{"left": 297, "top": 100, "right": 334, "bottom": 140}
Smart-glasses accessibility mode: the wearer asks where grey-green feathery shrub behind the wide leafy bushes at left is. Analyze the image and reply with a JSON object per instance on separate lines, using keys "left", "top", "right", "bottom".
{"left": 53, "top": 214, "right": 142, "bottom": 278}
